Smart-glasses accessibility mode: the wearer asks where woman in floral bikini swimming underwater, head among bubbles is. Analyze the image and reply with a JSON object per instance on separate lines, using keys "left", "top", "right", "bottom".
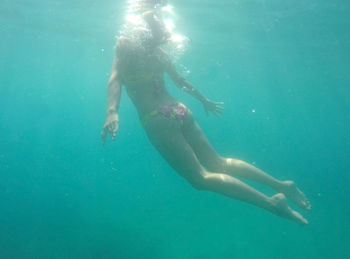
{"left": 101, "top": 6, "right": 310, "bottom": 224}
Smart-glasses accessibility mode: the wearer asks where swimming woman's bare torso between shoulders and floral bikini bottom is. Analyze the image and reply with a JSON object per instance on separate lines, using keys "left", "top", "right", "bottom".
{"left": 117, "top": 39, "right": 175, "bottom": 116}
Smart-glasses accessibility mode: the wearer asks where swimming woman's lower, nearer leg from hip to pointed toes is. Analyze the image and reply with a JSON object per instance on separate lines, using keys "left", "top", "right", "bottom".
{"left": 146, "top": 116, "right": 307, "bottom": 224}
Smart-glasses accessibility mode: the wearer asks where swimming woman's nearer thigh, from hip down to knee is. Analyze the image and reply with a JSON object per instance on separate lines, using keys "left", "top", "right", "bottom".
{"left": 145, "top": 116, "right": 205, "bottom": 185}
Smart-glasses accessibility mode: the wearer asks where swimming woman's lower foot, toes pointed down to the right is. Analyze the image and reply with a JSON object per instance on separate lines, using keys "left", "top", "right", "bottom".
{"left": 271, "top": 193, "right": 308, "bottom": 225}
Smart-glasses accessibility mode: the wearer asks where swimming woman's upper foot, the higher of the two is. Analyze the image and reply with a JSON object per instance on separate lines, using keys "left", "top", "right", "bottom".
{"left": 278, "top": 181, "right": 311, "bottom": 210}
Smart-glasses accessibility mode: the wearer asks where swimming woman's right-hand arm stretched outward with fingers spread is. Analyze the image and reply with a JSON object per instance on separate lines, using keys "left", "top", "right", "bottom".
{"left": 163, "top": 53, "right": 224, "bottom": 116}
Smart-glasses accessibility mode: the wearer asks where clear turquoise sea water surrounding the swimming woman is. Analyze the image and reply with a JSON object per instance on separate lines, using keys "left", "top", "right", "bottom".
{"left": 0, "top": 0, "right": 350, "bottom": 259}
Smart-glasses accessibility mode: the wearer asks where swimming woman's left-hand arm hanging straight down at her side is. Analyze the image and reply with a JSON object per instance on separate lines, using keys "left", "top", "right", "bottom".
{"left": 101, "top": 54, "right": 122, "bottom": 145}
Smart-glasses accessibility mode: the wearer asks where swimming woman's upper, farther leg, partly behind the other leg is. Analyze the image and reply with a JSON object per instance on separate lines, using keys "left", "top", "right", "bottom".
{"left": 182, "top": 114, "right": 310, "bottom": 210}
